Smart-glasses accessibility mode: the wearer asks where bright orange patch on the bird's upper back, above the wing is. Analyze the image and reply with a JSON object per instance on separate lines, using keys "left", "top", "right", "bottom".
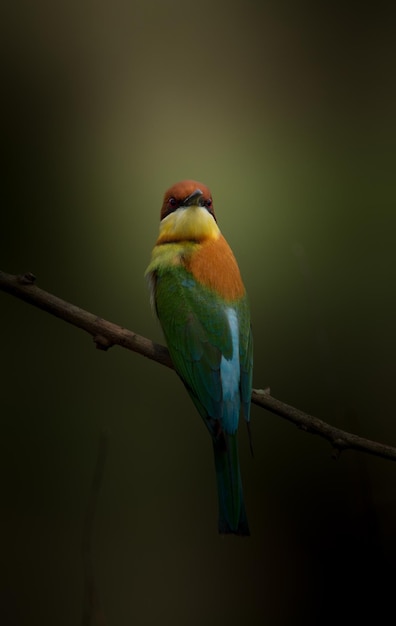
{"left": 186, "top": 235, "right": 245, "bottom": 300}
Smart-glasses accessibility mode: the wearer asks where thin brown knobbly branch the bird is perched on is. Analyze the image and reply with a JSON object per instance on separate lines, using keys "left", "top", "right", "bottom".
{"left": 0, "top": 271, "right": 396, "bottom": 461}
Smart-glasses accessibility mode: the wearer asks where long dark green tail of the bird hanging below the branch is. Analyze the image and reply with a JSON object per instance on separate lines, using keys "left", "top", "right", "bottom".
{"left": 213, "top": 433, "right": 250, "bottom": 535}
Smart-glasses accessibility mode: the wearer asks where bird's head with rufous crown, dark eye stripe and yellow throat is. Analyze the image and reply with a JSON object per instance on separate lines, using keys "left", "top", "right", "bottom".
{"left": 158, "top": 180, "right": 220, "bottom": 243}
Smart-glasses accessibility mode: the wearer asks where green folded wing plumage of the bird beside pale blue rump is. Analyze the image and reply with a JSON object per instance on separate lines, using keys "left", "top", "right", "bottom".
{"left": 154, "top": 266, "right": 252, "bottom": 437}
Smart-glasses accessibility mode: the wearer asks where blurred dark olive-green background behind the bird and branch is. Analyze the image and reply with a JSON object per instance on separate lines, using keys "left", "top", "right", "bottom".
{"left": 0, "top": 0, "right": 396, "bottom": 626}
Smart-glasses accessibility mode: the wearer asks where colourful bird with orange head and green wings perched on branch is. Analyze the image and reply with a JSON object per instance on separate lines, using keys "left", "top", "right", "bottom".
{"left": 145, "top": 180, "right": 253, "bottom": 536}
